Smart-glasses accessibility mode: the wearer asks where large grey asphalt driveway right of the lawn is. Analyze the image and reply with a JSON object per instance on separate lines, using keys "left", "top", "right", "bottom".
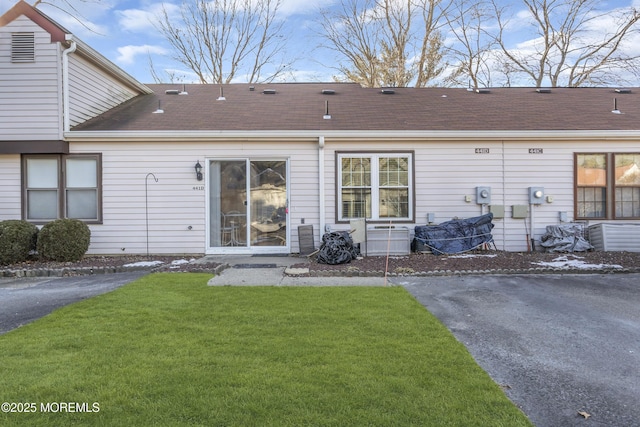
{"left": 393, "top": 274, "right": 640, "bottom": 427}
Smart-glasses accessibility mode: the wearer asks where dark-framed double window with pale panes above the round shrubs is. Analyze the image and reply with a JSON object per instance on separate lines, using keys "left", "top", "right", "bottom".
{"left": 23, "top": 154, "right": 102, "bottom": 222}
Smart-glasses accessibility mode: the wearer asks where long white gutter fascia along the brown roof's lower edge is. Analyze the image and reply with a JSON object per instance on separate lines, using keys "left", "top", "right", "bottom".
{"left": 64, "top": 130, "right": 640, "bottom": 142}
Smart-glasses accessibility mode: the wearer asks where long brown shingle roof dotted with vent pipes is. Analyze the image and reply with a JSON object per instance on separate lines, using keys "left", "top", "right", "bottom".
{"left": 73, "top": 83, "right": 640, "bottom": 131}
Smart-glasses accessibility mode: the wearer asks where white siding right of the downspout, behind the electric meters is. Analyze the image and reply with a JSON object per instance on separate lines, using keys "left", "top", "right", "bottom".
{"left": 325, "top": 139, "right": 637, "bottom": 251}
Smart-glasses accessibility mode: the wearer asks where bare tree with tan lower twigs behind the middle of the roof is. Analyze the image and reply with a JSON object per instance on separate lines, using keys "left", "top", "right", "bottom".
{"left": 320, "top": 0, "right": 450, "bottom": 87}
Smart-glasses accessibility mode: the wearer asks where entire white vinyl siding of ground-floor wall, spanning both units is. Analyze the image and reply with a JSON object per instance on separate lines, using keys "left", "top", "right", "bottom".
{"left": 5, "top": 138, "right": 638, "bottom": 254}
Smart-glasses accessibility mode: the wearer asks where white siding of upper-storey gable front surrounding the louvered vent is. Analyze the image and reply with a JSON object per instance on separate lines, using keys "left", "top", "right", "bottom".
{"left": 0, "top": 16, "right": 61, "bottom": 140}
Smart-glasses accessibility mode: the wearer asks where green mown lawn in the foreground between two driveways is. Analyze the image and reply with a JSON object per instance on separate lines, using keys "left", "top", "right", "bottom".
{"left": 0, "top": 273, "right": 531, "bottom": 427}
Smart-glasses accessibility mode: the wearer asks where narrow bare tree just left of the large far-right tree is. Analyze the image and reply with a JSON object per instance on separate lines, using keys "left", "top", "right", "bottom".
{"left": 446, "top": 0, "right": 500, "bottom": 89}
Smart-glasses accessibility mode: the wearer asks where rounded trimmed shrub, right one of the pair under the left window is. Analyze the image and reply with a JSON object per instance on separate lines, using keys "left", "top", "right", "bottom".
{"left": 37, "top": 219, "right": 91, "bottom": 262}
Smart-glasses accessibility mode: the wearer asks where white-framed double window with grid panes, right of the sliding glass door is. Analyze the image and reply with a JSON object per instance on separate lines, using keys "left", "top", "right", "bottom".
{"left": 337, "top": 152, "right": 413, "bottom": 221}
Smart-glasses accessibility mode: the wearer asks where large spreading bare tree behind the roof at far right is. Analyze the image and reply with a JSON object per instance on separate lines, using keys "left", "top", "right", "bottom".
{"left": 492, "top": 0, "right": 640, "bottom": 87}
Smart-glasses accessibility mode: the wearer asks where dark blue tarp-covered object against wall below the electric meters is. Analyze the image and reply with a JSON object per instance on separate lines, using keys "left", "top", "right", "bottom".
{"left": 414, "top": 213, "right": 493, "bottom": 255}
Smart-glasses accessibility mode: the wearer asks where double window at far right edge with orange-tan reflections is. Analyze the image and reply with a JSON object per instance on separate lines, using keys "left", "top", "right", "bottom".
{"left": 575, "top": 153, "right": 640, "bottom": 219}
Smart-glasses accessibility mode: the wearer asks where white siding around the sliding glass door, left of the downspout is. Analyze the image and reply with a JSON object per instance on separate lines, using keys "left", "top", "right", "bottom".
{"left": 71, "top": 140, "right": 320, "bottom": 254}
